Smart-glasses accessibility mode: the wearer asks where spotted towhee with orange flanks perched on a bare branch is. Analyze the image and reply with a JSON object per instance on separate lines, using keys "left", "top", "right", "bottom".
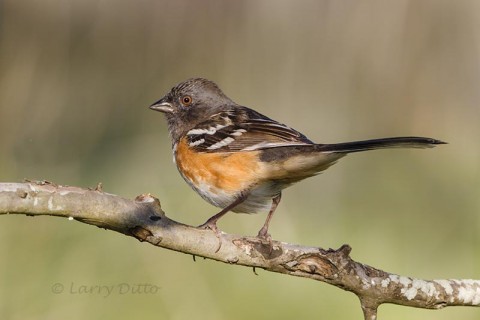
{"left": 150, "top": 78, "right": 444, "bottom": 238}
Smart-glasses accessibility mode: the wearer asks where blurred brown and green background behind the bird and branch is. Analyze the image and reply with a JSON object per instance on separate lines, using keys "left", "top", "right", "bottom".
{"left": 0, "top": 0, "right": 480, "bottom": 319}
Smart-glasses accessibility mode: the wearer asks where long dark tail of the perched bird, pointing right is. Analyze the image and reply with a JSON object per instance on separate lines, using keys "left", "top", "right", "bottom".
{"left": 317, "top": 137, "right": 446, "bottom": 153}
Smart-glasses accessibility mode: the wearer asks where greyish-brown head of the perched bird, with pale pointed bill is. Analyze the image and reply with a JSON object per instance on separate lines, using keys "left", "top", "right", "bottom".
{"left": 150, "top": 78, "right": 236, "bottom": 142}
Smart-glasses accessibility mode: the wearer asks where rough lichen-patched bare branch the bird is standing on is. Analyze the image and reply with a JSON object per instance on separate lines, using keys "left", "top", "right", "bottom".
{"left": 0, "top": 181, "right": 480, "bottom": 320}
